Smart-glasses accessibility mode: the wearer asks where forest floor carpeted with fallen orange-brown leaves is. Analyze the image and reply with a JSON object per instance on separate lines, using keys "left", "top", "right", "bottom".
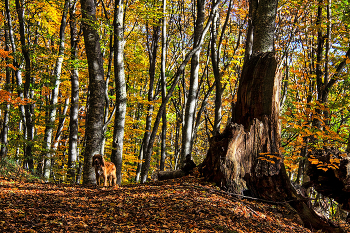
{"left": 0, "top": 172, "right": 320, "bottom": 233}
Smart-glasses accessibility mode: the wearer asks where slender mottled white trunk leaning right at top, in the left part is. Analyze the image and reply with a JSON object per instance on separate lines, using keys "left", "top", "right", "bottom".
{"left": 43, "top": 0, "right": 69, "bottom": 180}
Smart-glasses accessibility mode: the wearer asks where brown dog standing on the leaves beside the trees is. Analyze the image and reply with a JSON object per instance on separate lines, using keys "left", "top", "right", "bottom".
{"left": 92, "top": 154, "right": 117, "bottom": 186}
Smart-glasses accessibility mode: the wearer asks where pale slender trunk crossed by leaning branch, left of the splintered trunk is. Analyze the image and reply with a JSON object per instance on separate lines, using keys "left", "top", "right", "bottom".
{"left": 181, "top": 0, "right": 205, "bottom": 160}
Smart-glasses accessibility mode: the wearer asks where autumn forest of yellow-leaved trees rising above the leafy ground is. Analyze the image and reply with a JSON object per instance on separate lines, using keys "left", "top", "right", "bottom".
{"left": 0, "top": 0, "right": 350, "bottom": 232}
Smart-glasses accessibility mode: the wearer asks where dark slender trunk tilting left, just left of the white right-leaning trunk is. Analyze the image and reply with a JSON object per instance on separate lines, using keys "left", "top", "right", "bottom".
{"left": 15, "top": 0, "right": 34, "bottom": 172}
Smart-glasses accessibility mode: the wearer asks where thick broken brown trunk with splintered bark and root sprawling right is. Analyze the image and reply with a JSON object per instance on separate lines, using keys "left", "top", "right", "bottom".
{"left": 201, "top": 52, "right": 339, "bottom": 232}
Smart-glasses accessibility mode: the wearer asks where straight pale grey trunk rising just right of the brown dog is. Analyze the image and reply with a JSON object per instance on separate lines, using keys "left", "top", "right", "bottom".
{"left": 111, "top": 0, "right": 127, "bottom": 185}
